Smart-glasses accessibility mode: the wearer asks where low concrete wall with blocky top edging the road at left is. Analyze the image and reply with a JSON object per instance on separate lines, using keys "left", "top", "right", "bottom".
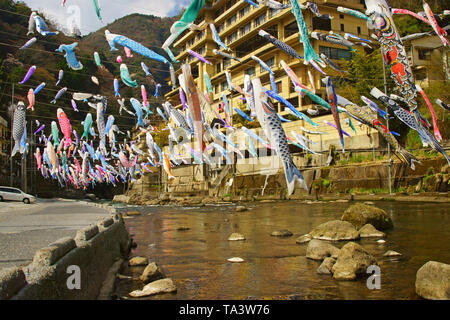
{"left": 0, "top": 205, "right": 131, "bottom": 300}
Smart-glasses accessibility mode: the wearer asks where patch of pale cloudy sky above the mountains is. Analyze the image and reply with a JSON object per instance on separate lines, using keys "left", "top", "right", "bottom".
{"left": 21, "top": 0, "right": 191, "bottom": 35}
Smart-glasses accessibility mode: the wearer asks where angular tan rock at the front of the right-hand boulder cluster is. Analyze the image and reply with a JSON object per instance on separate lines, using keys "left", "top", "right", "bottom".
{"left": 331, "top": 242, "right": 378, "bottom": 280}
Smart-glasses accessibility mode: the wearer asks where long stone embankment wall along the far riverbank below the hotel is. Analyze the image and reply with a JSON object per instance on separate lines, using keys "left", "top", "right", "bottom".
{"left": 154, "top": 157, "right": 448, "bottom": 199}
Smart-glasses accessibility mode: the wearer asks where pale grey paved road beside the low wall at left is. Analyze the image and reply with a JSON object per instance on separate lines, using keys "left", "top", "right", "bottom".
{"left": 0, "top": 199, "right": 109, "bottom": 269}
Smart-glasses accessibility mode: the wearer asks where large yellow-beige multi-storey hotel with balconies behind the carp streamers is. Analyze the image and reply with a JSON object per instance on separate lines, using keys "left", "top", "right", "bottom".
{"left": 165, "top": 0, "right": 379, "bottom": 160}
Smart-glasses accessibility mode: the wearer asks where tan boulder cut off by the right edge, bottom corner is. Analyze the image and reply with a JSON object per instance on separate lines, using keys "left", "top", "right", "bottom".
{"left": 416, "top": 261, "right": 450, "bottom": 300}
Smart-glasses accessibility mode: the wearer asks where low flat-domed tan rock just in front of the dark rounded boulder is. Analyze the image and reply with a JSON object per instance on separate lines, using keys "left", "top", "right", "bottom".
{"left": 309, "top": 220, "right": 359, "bottom": 241}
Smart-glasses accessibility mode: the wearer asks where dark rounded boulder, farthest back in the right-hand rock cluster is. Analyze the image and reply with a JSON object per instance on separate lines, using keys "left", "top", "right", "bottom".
{"left": 341, "top": 203, "right": 394, "bottom": 230}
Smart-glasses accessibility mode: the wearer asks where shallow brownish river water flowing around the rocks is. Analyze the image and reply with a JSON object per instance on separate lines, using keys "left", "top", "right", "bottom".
{"left": 116, "top": 201, "right": 450, "bottom": 299}
